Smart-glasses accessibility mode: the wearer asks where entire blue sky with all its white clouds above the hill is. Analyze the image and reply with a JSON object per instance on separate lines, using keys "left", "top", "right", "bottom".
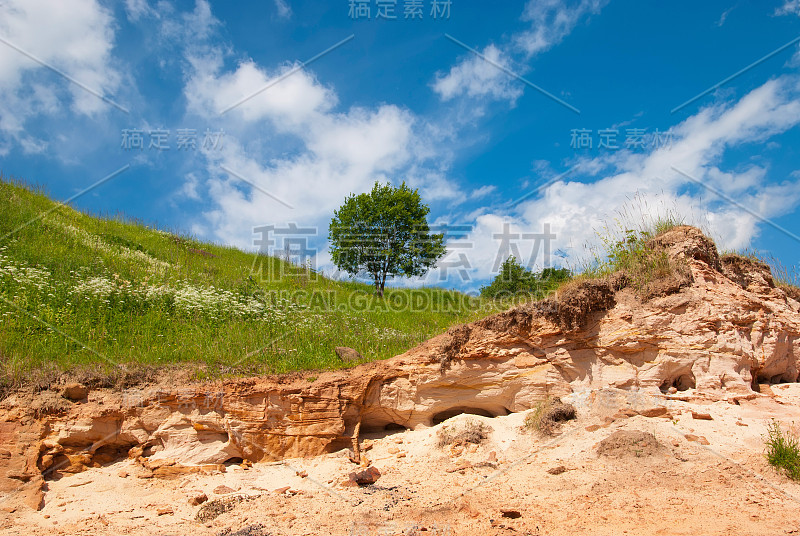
{"left": 0, "top": 0, "right": 800, "bottom": 290}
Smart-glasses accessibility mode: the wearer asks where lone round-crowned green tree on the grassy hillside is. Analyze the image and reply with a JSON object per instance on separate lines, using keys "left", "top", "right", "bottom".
{"left": 328, "top": 181, "right": 446, "bottom": 298}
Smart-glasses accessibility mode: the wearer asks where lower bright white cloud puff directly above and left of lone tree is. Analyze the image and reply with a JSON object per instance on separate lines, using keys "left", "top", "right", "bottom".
{"left": 191, "top": 100, "right": 413, "bottom": 247}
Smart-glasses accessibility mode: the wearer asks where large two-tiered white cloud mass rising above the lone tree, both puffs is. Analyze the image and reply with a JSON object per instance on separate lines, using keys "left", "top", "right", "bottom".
{"left": 178, "top": 4, "right": 463, "bottom": 251}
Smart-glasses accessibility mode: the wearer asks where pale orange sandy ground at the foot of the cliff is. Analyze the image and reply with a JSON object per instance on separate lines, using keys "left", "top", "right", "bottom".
{"left": 0, "top": 384, "right": 800, "bottom": 536}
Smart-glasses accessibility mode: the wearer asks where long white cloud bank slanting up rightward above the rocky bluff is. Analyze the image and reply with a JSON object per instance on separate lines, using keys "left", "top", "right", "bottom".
{"left": 454, "top": 77, "right": 800, "bottom": 279}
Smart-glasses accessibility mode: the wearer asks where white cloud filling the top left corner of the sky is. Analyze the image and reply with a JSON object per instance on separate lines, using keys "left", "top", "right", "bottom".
{"left": 0, "top": 0, "right": 120, "bottom": 146}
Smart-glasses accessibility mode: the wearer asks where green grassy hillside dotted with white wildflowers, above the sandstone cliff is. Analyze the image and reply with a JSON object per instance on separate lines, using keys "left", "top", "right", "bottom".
{"left": 0, "top": 178, "right": 497, "bottom": 387}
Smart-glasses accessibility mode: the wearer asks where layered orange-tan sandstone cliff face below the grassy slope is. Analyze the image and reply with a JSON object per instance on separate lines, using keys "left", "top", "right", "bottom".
{"left": 0, "top": 226, "right": 800, "bottom": 507}
